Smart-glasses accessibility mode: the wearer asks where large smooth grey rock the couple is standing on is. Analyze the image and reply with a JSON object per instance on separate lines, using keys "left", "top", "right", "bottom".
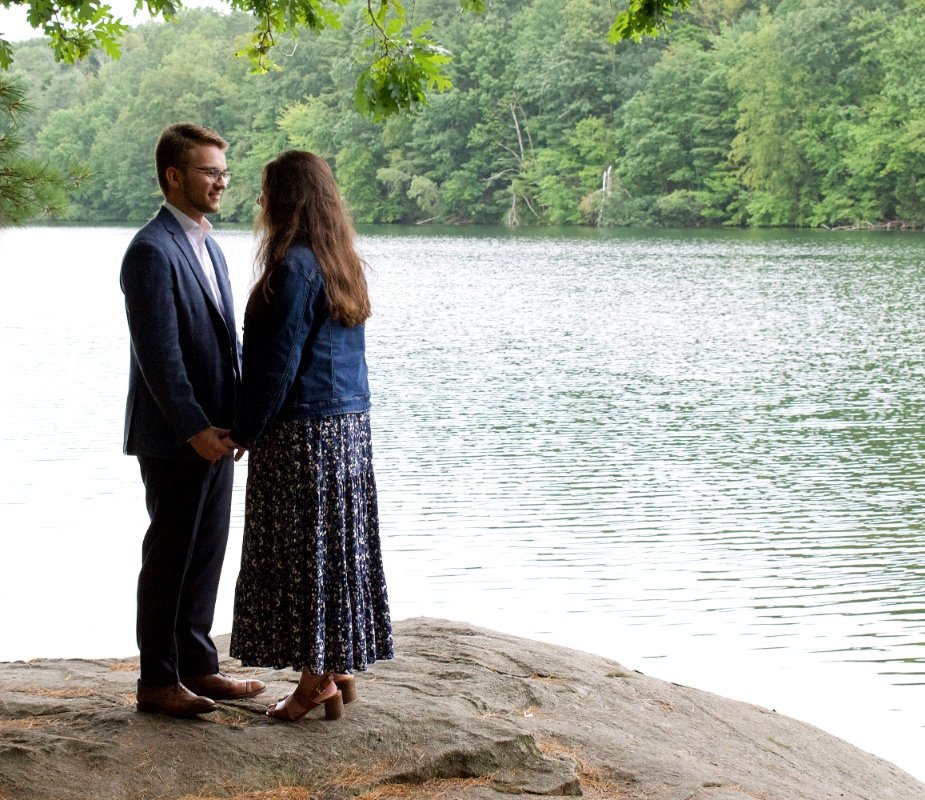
{"left": 0, "top": 619, "right": 925, "bottom": 800}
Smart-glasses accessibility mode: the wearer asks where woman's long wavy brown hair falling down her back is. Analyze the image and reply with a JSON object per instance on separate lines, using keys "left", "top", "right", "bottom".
{"left": 251, "top": 150, "right": 372, "bottom": 327}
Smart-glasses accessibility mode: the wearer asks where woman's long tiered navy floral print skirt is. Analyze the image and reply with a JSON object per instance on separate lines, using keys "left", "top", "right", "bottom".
{"left": 230, "top": 412, "right": 392, "bottom": 674}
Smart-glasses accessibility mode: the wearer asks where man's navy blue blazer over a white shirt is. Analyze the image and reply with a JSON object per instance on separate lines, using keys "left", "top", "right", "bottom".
{"left": 120, "top": 207, "right": 241, "bottom": 458}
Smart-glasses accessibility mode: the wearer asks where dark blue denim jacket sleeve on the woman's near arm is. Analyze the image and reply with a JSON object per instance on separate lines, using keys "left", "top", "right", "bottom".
{"left": 231, "top": 249, "right": 323, "bottom": 447}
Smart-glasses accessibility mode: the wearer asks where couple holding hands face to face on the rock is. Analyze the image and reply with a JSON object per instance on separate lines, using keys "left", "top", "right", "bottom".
{"left": 121, "top": 123, "right": 392, "bottom": 721}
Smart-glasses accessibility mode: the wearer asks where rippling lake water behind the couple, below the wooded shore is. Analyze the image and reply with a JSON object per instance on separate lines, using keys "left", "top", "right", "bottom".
{"left": 0, "top": 227, "right": 925, "bottom": 780}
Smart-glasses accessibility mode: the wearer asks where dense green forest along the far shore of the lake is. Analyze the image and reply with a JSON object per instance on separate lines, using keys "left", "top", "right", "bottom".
{"left": 5, "top": 0, "right": 925, "bottom": 228}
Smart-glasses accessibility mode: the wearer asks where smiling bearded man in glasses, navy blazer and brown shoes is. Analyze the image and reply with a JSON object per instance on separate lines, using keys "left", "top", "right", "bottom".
{"left": 121, "top": 123, "right": 266, "bottom": 717}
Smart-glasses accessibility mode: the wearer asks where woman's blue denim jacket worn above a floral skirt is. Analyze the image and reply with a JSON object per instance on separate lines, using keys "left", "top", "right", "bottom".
{"left": 231, "top": 245, "right": 370, "bottom": 447}
